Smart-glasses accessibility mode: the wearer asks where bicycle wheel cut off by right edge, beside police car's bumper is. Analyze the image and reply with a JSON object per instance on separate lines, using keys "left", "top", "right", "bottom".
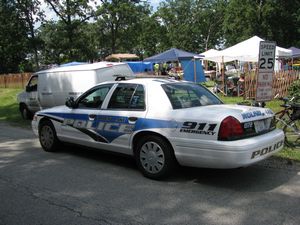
{"left": 283, "top": 120, "right": 300, "bottom": 150}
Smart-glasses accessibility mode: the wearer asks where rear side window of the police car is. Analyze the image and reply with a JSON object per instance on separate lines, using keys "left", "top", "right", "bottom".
{"left": 108, "top": 84, "right": 145, "bottom": 110}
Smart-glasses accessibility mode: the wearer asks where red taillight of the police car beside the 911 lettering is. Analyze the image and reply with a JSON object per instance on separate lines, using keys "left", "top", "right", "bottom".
{"left": 219, "top": 116, "right": 244, "bottom": 141}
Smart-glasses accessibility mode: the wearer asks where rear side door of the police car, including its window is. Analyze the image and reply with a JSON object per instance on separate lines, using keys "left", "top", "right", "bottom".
{"left": 98, "top": 83, "right": 146, "bottom": 154}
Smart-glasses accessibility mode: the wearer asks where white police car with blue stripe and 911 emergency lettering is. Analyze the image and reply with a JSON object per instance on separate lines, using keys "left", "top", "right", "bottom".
{"left": 32, "top": 78, "right": 284, "bottom": 179}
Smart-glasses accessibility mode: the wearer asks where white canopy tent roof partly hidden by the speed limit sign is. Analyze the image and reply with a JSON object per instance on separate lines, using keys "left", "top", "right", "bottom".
{"left": 203, "top": 36, "right": 292, "bottom": 63}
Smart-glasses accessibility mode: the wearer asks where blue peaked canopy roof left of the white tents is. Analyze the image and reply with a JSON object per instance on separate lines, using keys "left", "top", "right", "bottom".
{"left": 144, "top": 48, "right": 201, "bottom": 63}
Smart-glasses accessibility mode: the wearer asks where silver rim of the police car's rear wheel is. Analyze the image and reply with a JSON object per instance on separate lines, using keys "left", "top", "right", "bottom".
{"left": 140, "top": 142, "right": 165, "bottom": 174}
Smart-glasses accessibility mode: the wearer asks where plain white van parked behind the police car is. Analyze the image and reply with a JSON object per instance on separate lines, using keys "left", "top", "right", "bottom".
{"left": 17, "top": 62, "right": 135, "bottom": 119}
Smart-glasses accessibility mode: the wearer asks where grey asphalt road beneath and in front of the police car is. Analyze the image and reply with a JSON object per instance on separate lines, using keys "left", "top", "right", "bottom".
{"left": 0, "top": 124, "right": 300, "bottom": 225}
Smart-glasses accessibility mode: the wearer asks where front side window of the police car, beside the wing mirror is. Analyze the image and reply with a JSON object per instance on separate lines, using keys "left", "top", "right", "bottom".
{"left": 78, "top": 85, "right": 112, "bottom": 109}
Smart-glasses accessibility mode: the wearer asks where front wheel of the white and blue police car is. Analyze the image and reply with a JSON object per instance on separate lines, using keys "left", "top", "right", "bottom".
{"left": 39, "top": 120, "right": 60, "bottom": 152}
